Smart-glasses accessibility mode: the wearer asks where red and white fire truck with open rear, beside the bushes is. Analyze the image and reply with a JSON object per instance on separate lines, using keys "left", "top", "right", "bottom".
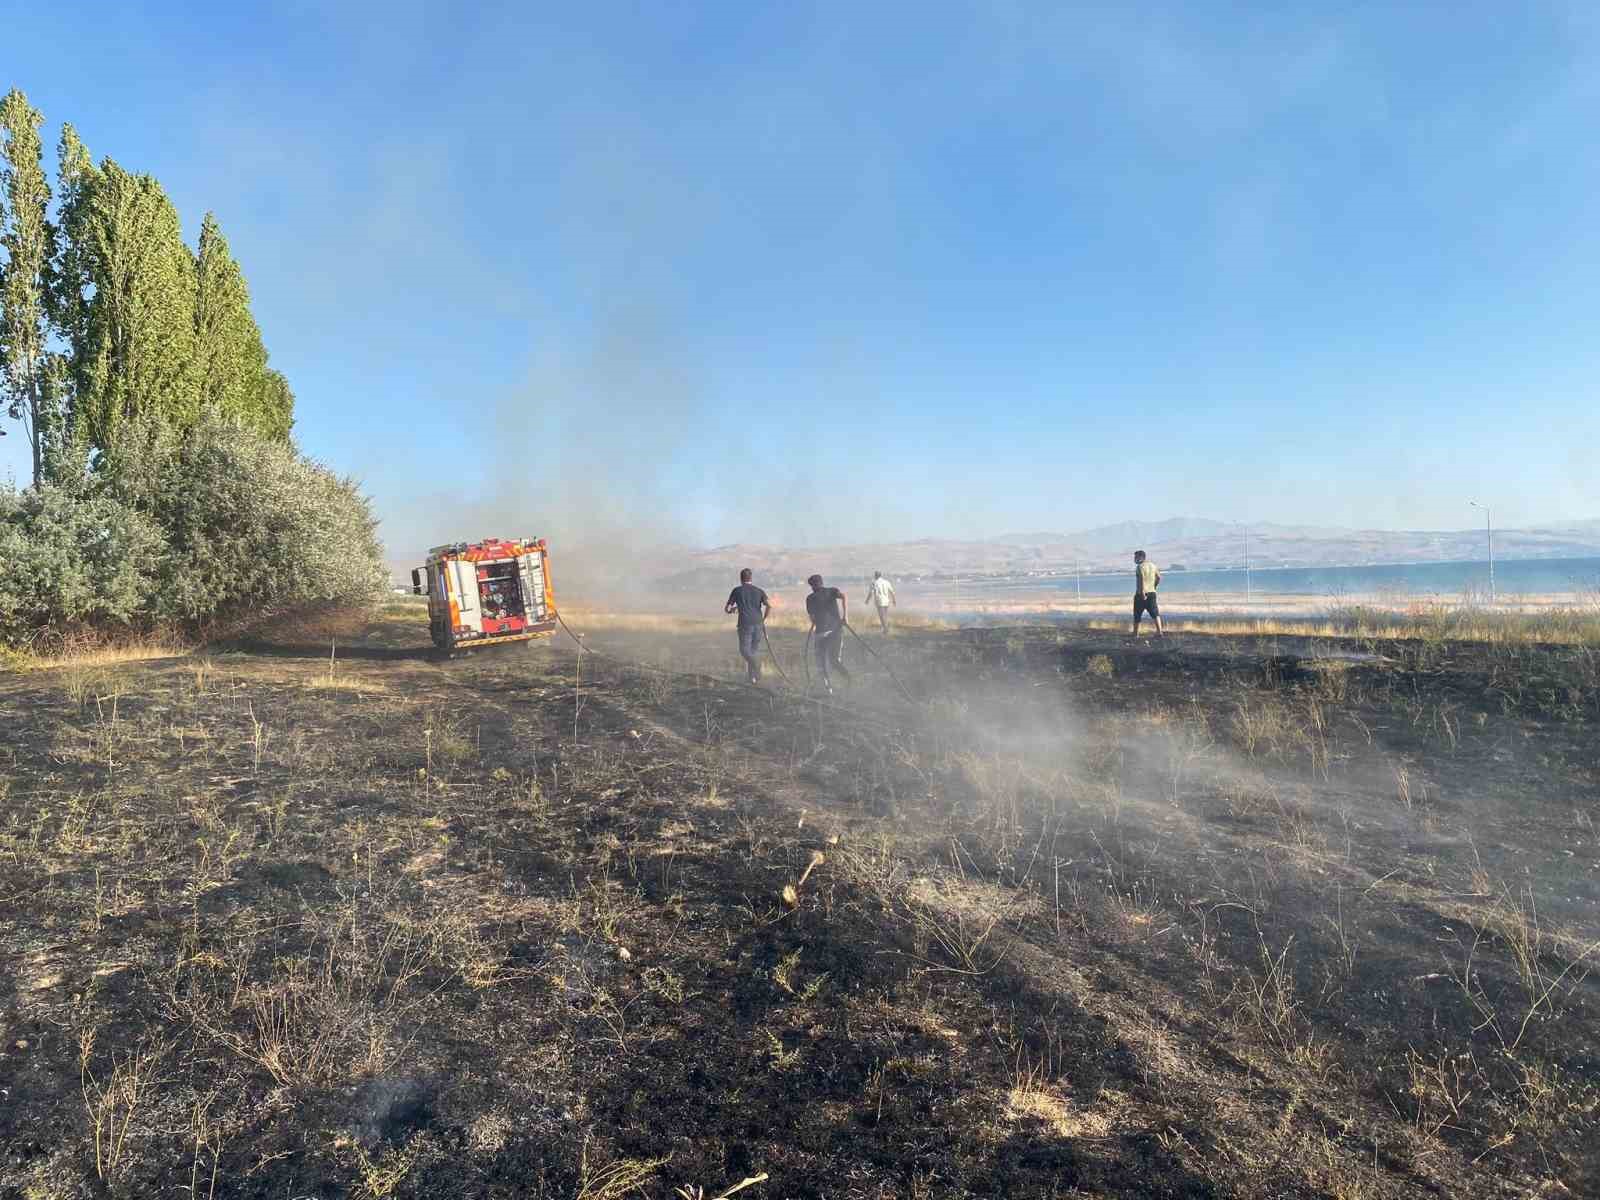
{"left": 411, "top": 538, "right": 555, "bottom": 653}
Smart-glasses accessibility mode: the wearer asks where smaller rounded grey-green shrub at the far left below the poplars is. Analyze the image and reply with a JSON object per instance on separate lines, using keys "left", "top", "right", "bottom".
{"left": 0, "top": 482, "right": 163, "bottom": 642}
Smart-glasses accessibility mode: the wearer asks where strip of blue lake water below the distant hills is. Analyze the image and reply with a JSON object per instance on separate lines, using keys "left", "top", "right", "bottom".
{"left": 968, "top": 558, "right": 1600, "bottom": 600}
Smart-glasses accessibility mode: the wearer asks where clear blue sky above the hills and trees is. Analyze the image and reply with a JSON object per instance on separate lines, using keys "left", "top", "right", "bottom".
{"left": 0, "top": 2, "right": 1600, "bottom": 552}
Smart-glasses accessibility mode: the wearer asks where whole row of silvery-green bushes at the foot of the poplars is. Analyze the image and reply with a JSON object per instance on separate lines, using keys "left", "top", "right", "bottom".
{"left": 0, "top": 413, "right": 387, "bottom": 643}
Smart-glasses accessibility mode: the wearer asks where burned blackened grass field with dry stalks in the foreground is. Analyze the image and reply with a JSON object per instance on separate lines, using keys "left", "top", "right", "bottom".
{"left": 0, "top": 605, "right": 1600, "bottom": 1200}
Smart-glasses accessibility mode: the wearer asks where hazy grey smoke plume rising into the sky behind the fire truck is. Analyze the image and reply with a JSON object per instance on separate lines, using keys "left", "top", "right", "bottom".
{"left": 382, "top": 309, "right": 942, "bottom": 603}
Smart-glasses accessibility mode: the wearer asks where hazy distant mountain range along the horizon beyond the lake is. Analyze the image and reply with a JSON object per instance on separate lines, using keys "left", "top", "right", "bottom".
{"left": 658, "top": 517, "right": 1600, "bottom": 589}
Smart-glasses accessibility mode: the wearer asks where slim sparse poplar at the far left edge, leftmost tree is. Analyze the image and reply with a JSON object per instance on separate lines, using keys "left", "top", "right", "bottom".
{"left": 0, "top": 88, "right": 64, "bottom": 486}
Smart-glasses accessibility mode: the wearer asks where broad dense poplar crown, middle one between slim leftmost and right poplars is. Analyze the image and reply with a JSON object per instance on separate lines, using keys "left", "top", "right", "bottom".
{"left": 62, "top": 158, "right": 200, "bottom": 450}
